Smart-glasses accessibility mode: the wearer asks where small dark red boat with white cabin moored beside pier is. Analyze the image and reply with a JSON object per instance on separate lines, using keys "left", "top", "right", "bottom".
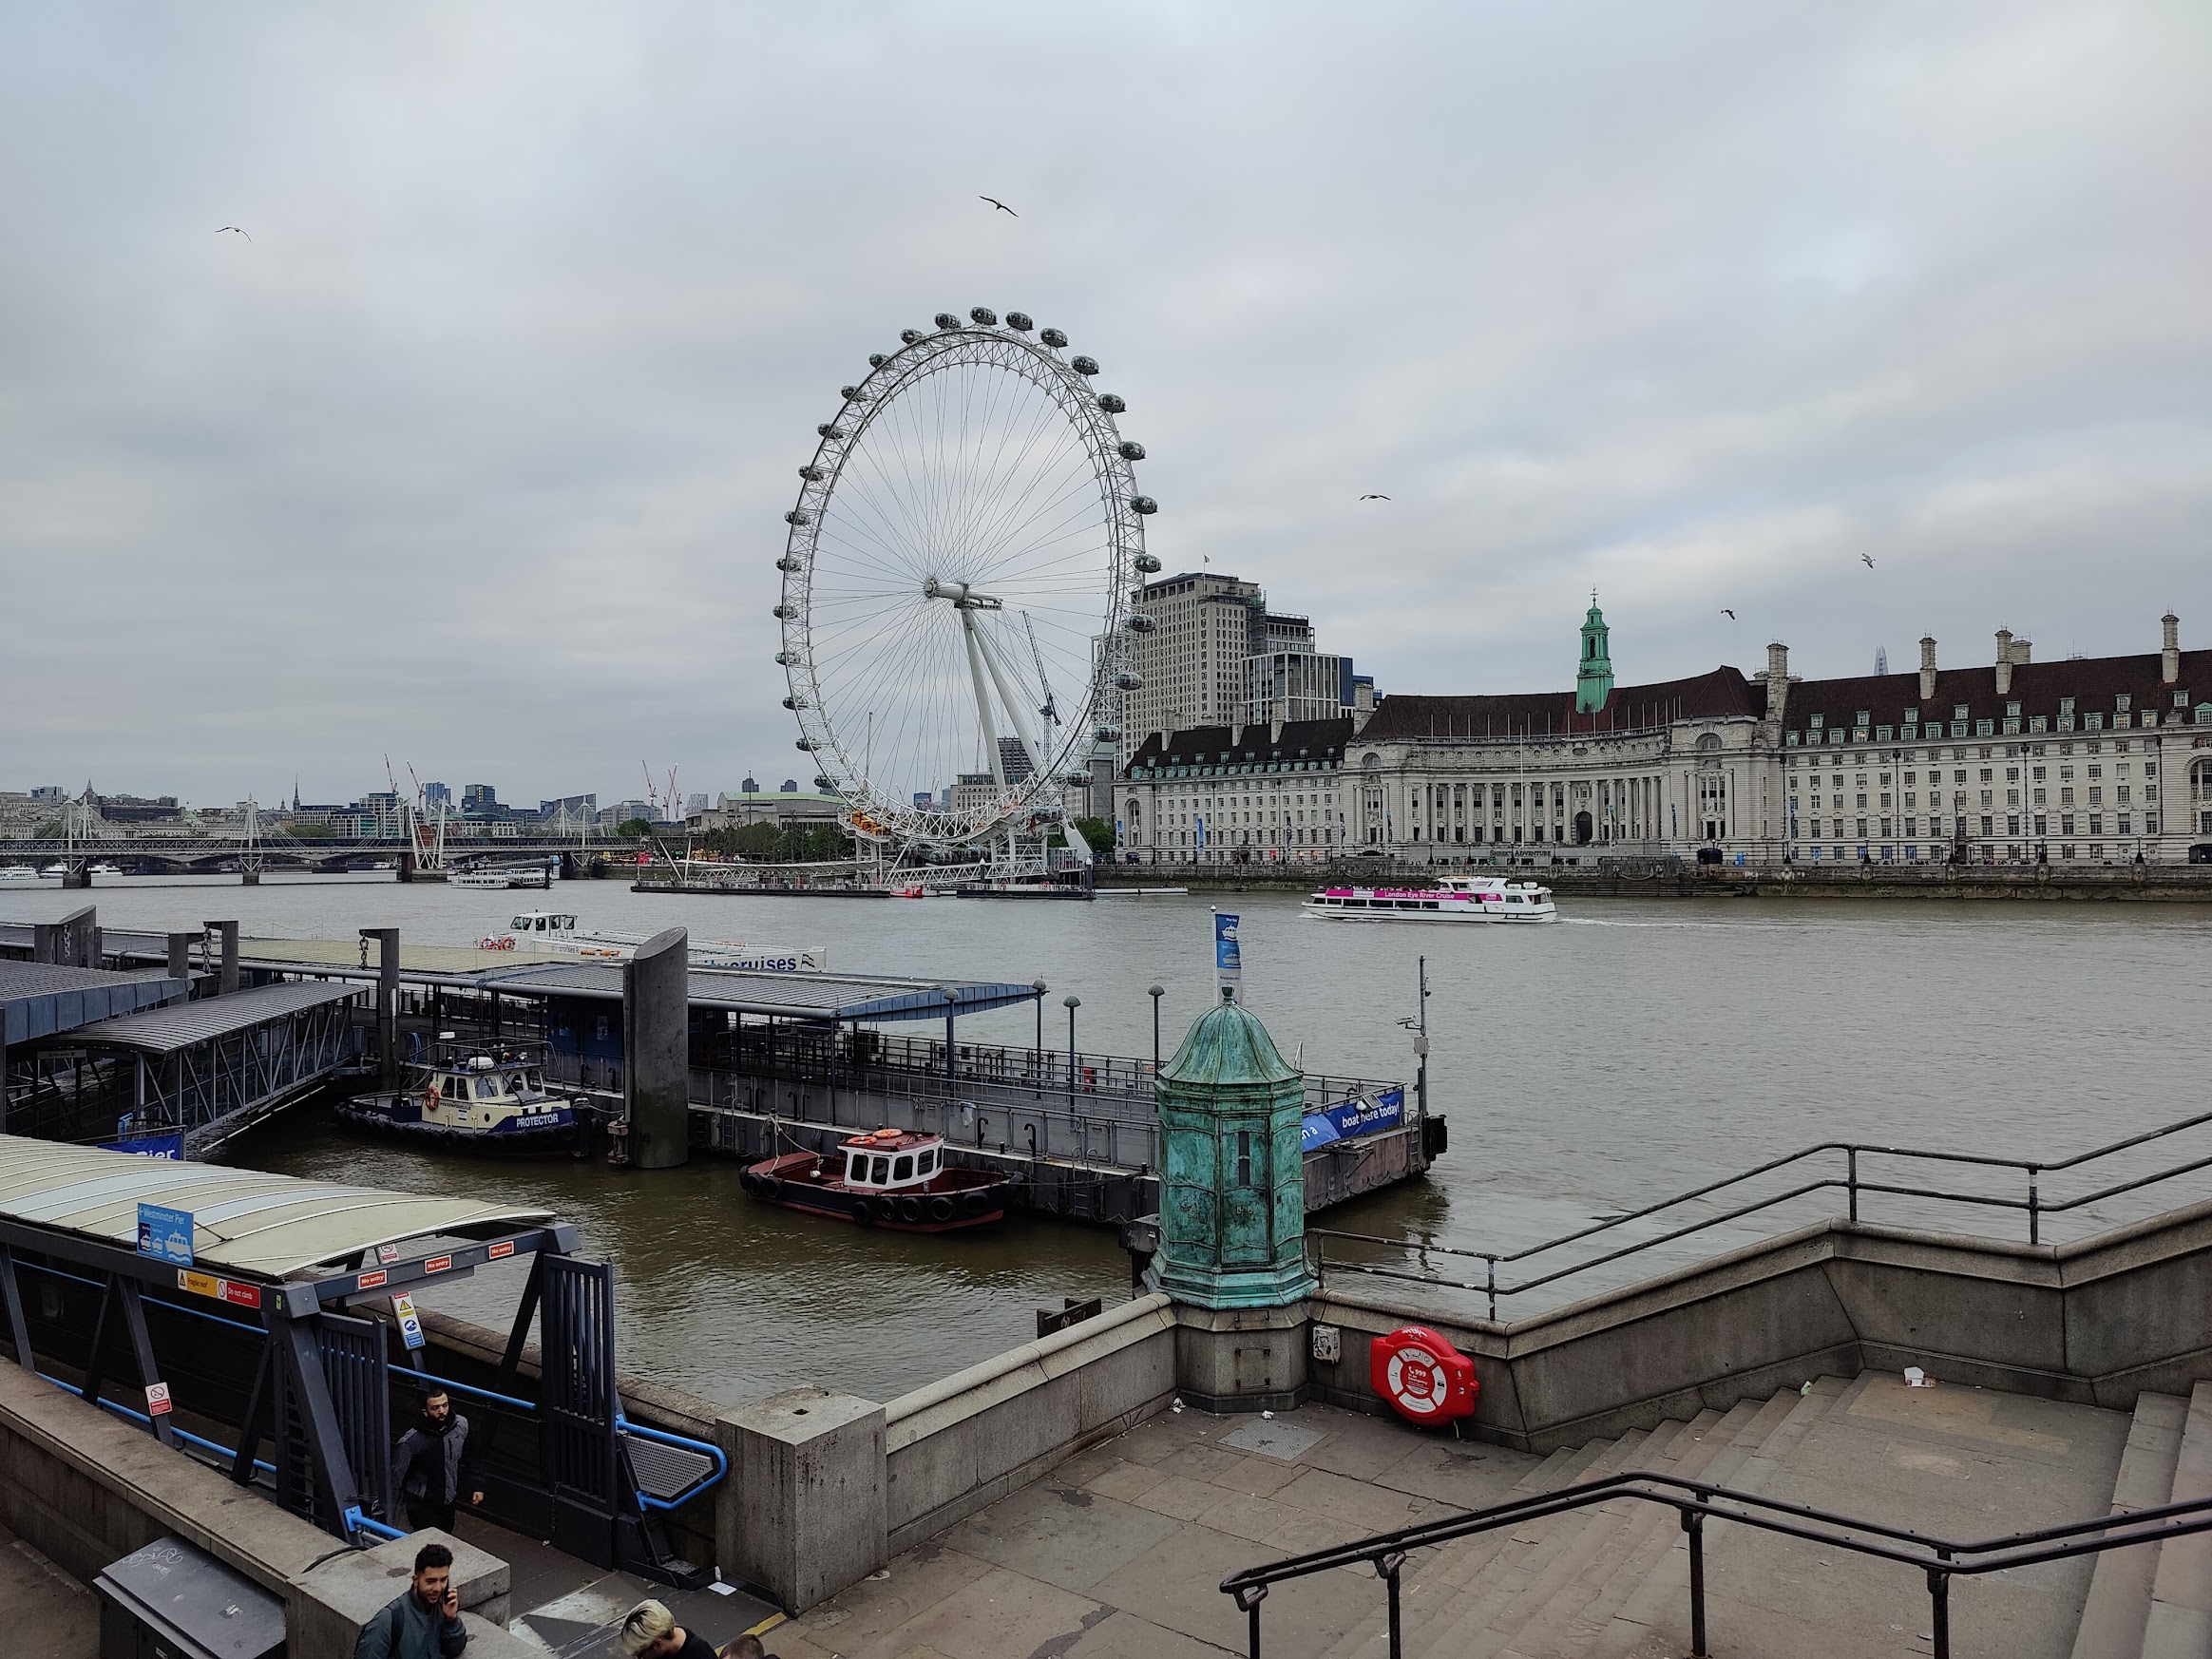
{"left": 736, "top": 1128, "right": 1013, "bottom": 1232}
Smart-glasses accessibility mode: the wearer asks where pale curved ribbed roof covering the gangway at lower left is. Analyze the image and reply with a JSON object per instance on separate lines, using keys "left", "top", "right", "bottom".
{"left": 0, "top": 1135, "right": 553, "bottom": 1279}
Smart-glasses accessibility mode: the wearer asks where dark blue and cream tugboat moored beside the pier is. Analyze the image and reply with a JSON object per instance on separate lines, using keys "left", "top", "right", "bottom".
{"left": 338, "top": 1041, "right": 593, "bottom": 1157}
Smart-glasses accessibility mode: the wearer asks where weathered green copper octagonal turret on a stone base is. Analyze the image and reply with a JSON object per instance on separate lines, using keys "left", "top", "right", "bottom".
{"left": 1153, "top": 993, "right": 1314, "bottom": 1411}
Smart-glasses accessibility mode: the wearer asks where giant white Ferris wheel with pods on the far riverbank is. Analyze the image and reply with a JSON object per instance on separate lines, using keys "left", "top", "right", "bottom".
{"left": 776, "top": 305, "right": 1159, "bottom": 856}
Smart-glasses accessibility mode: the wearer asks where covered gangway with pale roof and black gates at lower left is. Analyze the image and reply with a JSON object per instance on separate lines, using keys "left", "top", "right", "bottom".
{"left": 0, "top": 1135, "right": 728, "bottom": 1584}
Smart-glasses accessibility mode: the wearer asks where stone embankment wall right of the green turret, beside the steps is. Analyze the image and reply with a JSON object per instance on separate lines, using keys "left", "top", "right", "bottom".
{"left": 1307, "top": 1203, "right": 2212, "bottom": 1451}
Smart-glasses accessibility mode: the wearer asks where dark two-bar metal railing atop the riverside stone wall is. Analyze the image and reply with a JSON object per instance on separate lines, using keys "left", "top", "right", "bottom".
{"left": 1306, "top": 1113, "right": 2212, "bottom": 1321}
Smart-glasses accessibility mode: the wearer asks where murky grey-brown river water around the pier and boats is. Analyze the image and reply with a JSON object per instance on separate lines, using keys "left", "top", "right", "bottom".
{"left": 0, "top": 876, "right": 2212, "bottom": 1404}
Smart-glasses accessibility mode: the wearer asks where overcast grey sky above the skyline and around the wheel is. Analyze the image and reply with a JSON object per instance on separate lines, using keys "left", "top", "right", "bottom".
{"left": 0, "top": 0, "right": 2212, "bottom": 803}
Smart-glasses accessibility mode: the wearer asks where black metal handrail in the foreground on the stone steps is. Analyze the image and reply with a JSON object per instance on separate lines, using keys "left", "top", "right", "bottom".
{"left": 1221, "top": 1469, "right": 2212, "bottom": 1659}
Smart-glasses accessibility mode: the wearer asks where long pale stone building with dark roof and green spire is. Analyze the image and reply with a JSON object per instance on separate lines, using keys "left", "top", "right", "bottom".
{"left": 1115, "top": 600, "right": 2212, "bottom": 865}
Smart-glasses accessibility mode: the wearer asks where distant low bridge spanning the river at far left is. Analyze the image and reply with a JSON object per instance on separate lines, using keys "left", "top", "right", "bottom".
{"left": 0, "top": 801, "right": 633, "bottom": 887}
